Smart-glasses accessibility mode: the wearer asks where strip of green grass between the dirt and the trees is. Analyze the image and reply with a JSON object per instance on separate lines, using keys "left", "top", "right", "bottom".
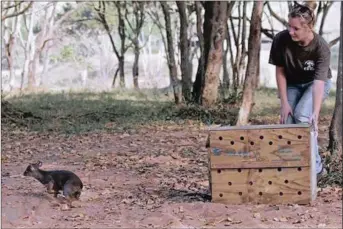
{"left": 1, "top": 88, "right": 335, "bottom": 134}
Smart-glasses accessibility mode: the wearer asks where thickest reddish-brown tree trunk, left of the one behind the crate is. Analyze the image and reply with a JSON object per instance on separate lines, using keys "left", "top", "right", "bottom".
{"left": 201, "top": 1, "right": 228, "bottom": 107}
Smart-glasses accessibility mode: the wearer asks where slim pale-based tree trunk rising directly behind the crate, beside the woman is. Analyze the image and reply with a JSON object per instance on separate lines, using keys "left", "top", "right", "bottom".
{"left": 236, "top": 1, "right": 263, "bottom": 125}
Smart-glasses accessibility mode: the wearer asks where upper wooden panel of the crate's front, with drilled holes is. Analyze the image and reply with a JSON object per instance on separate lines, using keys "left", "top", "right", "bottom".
{"left": 210, "top": 127, "right": 311, "bottom": 168}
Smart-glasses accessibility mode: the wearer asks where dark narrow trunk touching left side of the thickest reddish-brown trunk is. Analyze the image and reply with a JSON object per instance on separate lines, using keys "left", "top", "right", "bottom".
{"left": 192, "top": 1, "right": 209, "bottom": 104}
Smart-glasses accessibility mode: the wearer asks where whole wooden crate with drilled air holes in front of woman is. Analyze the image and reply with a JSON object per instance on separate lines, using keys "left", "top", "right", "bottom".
{"left": 209, "top": 124, "right": 317, "bottom": 204}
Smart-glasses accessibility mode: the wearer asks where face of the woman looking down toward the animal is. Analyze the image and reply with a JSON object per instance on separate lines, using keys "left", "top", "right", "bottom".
{"left": 288, "top": 17, "right": 312, "bottom": 42}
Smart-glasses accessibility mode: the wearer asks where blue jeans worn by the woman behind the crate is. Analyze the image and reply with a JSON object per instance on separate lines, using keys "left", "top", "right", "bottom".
{"left": 286, "top": 80, "right": 332, "bottom": 173}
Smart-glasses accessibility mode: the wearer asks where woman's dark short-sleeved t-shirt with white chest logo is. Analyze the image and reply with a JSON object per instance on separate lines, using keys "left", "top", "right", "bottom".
{"left": 269, "top": 30, "right": 332, "bottom": 84}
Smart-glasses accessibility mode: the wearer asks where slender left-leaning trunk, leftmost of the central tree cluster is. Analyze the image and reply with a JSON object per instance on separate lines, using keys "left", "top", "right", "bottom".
{"left": 161, "top": 1, "right": 182, "bottom": 104}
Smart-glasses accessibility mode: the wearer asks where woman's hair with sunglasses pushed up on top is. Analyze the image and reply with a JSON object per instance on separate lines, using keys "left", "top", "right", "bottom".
{"left": 288, "top": 1, "right": 317, "bottom": 28}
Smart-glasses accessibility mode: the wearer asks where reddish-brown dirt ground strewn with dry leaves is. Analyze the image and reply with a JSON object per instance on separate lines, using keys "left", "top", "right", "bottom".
{"left": 1, "top": 122, "right": 342, "bottom": 228}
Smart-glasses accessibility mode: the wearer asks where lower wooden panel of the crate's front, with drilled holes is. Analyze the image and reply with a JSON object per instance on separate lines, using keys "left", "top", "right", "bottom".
{"left": 211, "top": 167, "right": 311, "bottom": 204}
